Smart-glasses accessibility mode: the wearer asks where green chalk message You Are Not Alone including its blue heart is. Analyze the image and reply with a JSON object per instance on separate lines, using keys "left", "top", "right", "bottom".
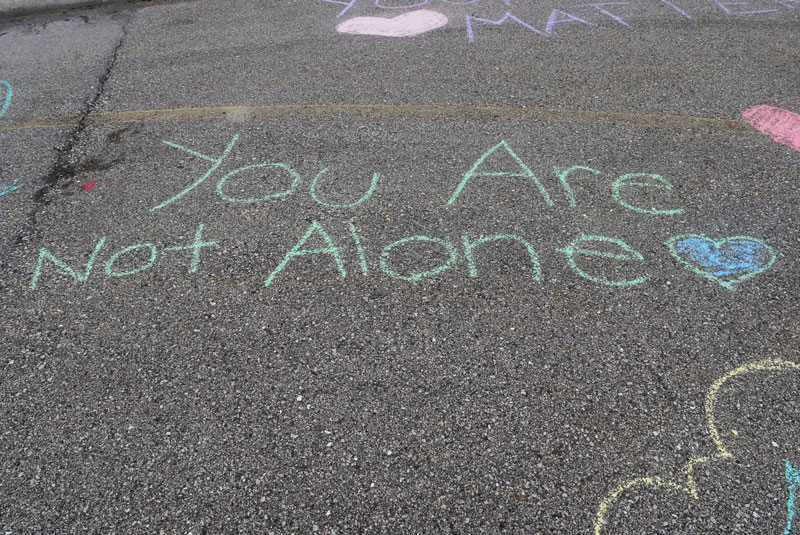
{"left": 23, "top": 134, "right": 776, "bottom": 290}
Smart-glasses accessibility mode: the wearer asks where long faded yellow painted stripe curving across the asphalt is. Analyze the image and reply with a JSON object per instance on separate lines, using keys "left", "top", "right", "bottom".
{"left": 0, "top": 104, "right": 764, "bottom": 135}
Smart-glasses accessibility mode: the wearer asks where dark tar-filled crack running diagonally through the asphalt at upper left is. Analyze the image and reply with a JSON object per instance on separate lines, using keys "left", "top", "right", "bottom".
{"left": 0, "top": 21, "right": 128, "bottom": 289}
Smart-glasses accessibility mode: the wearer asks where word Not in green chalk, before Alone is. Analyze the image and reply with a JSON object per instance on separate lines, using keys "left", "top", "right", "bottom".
{"left": 28, "top": 224, "right": 219, "bottom": 291}
